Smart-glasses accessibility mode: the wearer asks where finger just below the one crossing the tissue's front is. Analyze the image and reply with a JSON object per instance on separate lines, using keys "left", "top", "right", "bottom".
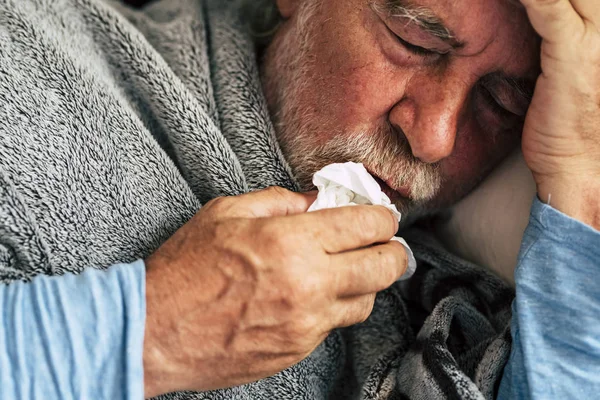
{"left": 328, "top": 241, "right": 408, "bottom": 297}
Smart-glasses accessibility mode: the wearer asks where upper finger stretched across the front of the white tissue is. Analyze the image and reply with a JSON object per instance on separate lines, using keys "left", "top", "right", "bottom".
{"left": 296, "top": 205, "right": 398, "bottom": 254}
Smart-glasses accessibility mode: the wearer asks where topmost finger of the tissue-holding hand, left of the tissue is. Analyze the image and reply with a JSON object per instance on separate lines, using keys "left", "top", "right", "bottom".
{"left": 223, "top": 186, "right": 317, "bottom": 218}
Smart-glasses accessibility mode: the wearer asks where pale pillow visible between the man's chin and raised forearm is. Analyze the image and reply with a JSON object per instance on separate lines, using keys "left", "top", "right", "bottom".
{"left": 435, "top": 151, "right": 536, "bottom": 285}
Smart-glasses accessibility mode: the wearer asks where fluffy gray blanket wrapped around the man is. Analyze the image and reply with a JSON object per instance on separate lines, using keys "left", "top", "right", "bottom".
{"left": 0, "top": 0, "right": 514, "bottom": 400}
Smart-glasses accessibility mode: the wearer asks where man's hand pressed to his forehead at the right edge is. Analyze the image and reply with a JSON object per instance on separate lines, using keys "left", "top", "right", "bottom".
{"left": 521, "top": 0, "right": 600, "bottom": 229}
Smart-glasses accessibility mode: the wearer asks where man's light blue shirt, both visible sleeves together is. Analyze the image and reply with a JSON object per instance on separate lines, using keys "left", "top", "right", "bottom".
{"left": 0, "top": 199, "right": 600, "bottom": 400}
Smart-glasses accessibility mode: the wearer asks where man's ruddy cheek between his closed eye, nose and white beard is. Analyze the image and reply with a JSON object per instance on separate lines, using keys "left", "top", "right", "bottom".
{"left": 309, "top": 8, "right": 404, "bottom": 126}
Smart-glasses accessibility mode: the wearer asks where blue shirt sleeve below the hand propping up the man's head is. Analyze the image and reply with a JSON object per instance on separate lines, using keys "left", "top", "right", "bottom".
{"left": 499, "top": 198, "right": 600, "bottom": 399}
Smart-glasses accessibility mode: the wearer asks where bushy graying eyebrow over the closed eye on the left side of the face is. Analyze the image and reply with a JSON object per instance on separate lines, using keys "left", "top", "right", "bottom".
{"left": 372, "top": 0, "right": 465, "bottom": 49}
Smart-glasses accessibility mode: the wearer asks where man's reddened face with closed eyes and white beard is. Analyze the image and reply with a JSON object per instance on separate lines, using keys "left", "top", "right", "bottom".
{"left": 262, "top": 0, "right": 539, "bottom": 219}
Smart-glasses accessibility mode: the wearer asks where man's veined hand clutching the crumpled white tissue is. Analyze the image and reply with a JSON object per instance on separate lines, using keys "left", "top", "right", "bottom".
{"left": 144, "top": 188, "right": 407, "bottom": 396}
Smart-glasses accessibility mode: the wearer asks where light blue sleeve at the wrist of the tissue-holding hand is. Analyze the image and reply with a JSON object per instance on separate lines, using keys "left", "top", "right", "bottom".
{"left": 0, "top": 261, "right": 146, "bottom": 400}
